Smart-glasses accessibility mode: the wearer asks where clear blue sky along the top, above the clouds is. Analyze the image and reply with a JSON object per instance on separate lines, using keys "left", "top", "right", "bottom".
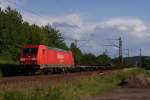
{"left": 22, "top": 0, "right": 150, "bottom": 21}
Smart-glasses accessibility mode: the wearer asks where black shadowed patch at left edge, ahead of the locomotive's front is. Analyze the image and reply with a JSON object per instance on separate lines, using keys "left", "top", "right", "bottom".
{"left": 0, "top": 64, "right": 25, "bottom": 77}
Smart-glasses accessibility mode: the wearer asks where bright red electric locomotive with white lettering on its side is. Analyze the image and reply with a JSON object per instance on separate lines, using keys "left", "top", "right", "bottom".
{"left": 20, "top": 45, "right": 74, "bottom": 70}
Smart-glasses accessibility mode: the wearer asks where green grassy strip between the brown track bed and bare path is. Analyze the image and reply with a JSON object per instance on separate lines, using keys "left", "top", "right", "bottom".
{"left": 0, "top": 69, "right": 146, "bottom": 100}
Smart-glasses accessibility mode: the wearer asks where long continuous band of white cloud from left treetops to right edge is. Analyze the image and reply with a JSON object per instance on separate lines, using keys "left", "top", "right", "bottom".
{"left": 23, "top": 12, "right": 150, "bottom": 39}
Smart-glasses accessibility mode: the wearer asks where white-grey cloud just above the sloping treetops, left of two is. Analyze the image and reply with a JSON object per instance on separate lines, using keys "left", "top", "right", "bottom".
{"left": 22, "top": 12, "right": 92, "bottom": 39}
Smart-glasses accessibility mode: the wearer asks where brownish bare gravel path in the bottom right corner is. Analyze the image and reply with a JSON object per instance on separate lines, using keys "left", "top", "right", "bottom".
{"left": 84, "top": 88, "right": 150, "bottom": 100}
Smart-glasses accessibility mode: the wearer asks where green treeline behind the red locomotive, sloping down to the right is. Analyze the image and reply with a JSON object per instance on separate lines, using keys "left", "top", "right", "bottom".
{"left": 0, "top": 7, "right": 111, "bottom": 65}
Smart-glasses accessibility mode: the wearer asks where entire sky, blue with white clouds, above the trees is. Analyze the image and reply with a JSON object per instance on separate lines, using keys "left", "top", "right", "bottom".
{"left": 0, "top": 0, "right": 150, "bottom": 56}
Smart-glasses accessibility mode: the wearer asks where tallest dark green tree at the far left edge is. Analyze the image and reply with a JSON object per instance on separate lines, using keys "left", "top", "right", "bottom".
{"left": 0, "top": 7, "right": 25, "bottom": 59}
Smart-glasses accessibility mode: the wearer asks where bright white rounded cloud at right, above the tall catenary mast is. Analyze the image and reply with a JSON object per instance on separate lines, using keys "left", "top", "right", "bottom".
{"left": 96, "top": 17, "right": 149, "bottom": 38}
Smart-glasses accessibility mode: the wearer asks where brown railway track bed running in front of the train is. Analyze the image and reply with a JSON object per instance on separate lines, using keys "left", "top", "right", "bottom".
{"left": 0, "top": 70, "right": 115, "bottom": 89}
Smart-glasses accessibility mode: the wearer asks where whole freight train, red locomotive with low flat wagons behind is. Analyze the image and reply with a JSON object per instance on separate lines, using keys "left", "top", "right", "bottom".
{"left": 20, "top": 45, "right": 111, "bottom": 74}
